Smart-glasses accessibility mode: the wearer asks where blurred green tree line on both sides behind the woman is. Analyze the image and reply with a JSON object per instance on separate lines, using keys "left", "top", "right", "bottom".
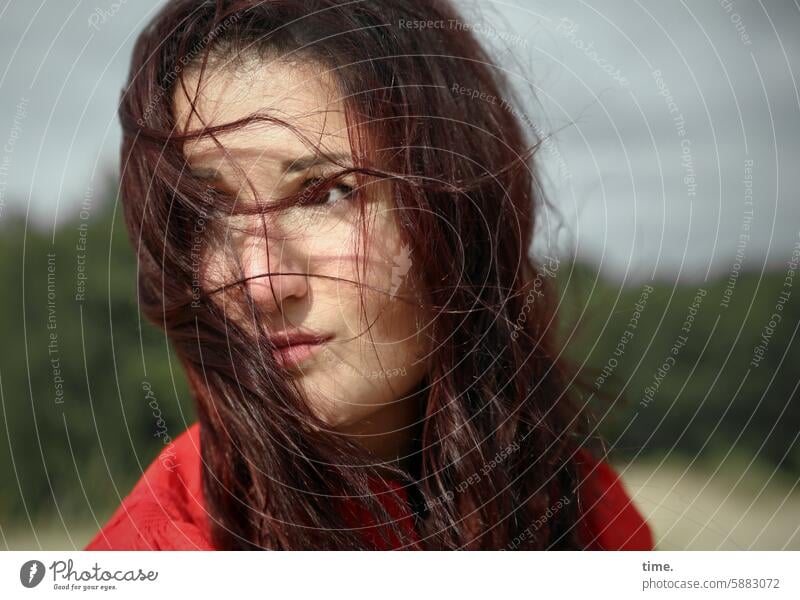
{"left": 0, "top": 180, "right": 800, "bottom": 530}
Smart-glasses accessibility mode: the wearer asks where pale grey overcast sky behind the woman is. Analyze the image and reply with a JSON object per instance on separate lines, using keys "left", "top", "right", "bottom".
{"left": 0, "top": 0, "right": 800, "bottom": 279}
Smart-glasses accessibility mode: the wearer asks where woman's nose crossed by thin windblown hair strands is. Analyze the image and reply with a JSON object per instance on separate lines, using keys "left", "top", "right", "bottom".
{"left": 242, "top": 236, "right": 308, "bottom": 312}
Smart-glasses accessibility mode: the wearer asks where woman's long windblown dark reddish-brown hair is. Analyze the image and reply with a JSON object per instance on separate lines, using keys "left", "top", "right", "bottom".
{"left": 120, "top": 0, "right": 586, "bottom": 549}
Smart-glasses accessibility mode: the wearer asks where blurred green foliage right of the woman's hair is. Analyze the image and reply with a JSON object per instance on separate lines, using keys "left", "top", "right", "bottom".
{"left": 558, "top": 264, "right": 800, "bottom": 475}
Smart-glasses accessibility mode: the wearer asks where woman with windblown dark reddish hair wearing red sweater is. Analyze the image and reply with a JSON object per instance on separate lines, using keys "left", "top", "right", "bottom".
{"left": 87, "top": 0, "right": 652, "bottom": 549}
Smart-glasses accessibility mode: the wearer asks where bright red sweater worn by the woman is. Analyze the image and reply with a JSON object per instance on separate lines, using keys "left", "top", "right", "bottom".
{"left": 85, "top": 423, "right": 653, "bottom": 550}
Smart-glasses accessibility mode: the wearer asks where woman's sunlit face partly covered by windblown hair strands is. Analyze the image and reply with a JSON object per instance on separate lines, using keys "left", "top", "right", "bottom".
{"left": 173, "top": 56, "right": 426, "bottom": 428}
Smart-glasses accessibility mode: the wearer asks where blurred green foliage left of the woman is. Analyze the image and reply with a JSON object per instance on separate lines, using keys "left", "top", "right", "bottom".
{"left": 0, "top": 185, "right": 195, "bottom": 529}
